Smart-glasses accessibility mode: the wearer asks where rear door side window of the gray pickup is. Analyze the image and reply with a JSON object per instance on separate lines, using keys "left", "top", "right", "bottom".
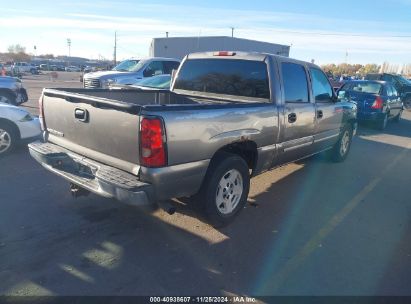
{"left": 281, "top": 62, "right": 308, "bottom": 102}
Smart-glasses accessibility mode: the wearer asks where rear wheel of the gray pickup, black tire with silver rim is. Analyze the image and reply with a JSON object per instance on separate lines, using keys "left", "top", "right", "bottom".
{"left": 194, "top": 152, "right": 250, "bottom": 227}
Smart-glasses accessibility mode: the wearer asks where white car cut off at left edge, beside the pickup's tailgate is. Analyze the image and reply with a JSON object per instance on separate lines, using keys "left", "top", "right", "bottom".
{"left": 0, "top": 102, "right": 41, "bottom": 157}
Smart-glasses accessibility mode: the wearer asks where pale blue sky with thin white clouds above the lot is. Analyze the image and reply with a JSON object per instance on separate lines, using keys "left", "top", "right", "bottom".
{"left": 0, "top": 0, "right": 411, "bottom": 64}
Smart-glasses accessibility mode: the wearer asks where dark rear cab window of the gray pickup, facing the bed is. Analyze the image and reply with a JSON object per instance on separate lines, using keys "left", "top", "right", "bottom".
{"left": 174, "top": 58, "right": 270, "bottom": 102}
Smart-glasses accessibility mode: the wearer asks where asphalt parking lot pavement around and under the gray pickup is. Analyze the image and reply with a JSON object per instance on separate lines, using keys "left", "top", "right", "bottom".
{"left": 0, "top": 73, "right": 411, "bottom": 296}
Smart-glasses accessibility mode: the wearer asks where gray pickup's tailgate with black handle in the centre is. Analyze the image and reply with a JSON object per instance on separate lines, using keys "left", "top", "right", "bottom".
{"left": 42, "top": 90, "right": 140, "bottom": 175}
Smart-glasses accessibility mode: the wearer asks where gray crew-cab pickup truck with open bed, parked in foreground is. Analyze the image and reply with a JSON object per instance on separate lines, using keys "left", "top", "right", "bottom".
{"left": 29, "top": 52, "right": 357, "bottom": 225}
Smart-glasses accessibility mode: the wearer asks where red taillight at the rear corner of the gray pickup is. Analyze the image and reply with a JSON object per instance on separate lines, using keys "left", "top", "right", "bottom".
{"left": 140, "top": 117, "right": 167, "bottom": 168}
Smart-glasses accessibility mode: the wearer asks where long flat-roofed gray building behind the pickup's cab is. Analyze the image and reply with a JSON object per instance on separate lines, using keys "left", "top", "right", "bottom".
{"left": 149, "top": 36, "right": 290, "bottom": 59}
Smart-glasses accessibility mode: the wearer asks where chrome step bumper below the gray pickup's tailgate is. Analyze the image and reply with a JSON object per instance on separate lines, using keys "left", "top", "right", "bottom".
{"left": 29, "top": 141, "right": 155, "bottom": 206}
